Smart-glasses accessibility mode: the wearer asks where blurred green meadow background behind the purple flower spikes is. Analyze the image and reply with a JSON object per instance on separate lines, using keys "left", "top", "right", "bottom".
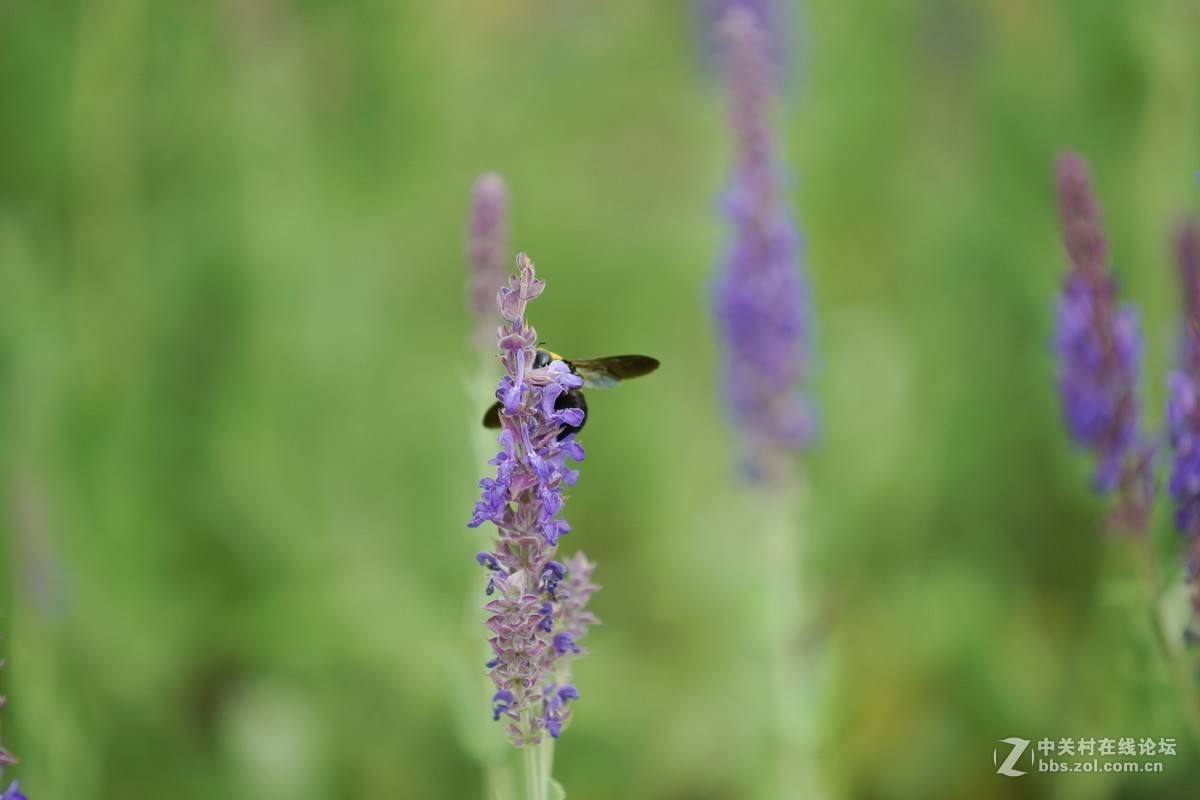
{"left": 0, "top": 0, "right": 1200, "bottom": 800}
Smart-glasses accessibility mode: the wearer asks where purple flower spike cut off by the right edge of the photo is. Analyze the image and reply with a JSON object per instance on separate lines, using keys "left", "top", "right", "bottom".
{"left": 1166, "top": 222, "right": 1200, "bottom": 599}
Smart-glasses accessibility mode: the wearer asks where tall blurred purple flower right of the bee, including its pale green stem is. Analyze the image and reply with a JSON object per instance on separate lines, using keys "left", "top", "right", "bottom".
{"left": 714, "top": 2, "right": 816, "bottom": 800}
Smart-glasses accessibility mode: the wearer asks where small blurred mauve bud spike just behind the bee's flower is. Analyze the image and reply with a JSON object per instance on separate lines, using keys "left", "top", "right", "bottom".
{"left": 467, "top": 173, "right": 509, "bottom": 347}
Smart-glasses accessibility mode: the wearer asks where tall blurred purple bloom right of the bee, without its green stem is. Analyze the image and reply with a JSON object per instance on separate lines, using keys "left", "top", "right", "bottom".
{"left": 715, "top": 6, "right": 815, "bottom": 474}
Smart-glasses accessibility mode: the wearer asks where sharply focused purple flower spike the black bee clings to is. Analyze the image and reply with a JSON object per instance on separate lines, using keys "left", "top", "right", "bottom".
{"left": 468, "top": 253, "right": 596, "bottom": 746}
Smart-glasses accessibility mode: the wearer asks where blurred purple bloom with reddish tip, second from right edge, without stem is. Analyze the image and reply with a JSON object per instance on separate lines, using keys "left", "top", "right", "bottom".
{"left": 1055, "top": 152, "right": 1153, "bottom": 533}
